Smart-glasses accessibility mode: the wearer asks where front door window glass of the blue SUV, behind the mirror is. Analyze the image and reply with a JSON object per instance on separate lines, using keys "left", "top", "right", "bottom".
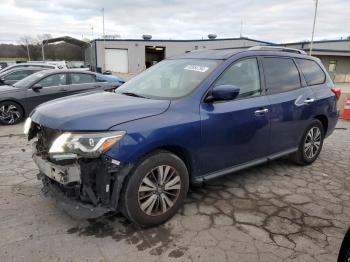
{"left": 215, "top": 58, "right": 260, "bottom": 97}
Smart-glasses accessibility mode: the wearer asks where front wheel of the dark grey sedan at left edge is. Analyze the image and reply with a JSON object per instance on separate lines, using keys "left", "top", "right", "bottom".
{"left": 0, "top": 101, "right": 24, "bottom": 125}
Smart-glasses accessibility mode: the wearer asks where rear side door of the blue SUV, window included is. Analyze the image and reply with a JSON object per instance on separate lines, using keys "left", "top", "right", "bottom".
{"left": 262, "top": 57, "right": 314, "bottom": 155}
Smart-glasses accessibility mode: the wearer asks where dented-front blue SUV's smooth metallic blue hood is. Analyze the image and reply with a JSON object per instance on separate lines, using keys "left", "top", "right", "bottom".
{"left": 31, "top": 92, "right": 170, "bottom": 131}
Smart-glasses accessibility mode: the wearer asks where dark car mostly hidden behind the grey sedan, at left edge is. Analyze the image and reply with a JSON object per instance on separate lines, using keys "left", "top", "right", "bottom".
{"left": 0, "top": 67, "right": 47, "bottom": 85}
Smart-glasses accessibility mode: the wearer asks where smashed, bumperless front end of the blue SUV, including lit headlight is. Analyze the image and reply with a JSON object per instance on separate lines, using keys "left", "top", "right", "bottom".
{"left": 31, "top": 126, "right": 131, "bottom": 217}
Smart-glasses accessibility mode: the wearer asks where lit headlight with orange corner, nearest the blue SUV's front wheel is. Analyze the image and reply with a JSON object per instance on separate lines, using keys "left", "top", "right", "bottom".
{"left": 49, "top": 131, "right": 125, "bottom": 157}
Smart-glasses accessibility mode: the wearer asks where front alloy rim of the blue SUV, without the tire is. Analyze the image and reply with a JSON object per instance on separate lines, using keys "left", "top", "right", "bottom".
{"left": 138, "top": 165, "right": 181, "bottom": 216}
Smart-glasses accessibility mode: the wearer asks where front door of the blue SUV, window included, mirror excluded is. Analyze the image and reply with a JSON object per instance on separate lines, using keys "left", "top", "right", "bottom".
{"left": 200, "top": 57, "right": 269, "bottom": 174}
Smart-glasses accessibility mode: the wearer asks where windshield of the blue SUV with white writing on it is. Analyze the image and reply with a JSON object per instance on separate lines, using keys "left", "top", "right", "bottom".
{"left": 116, "top": 59, "right": 220, "bottom": 99}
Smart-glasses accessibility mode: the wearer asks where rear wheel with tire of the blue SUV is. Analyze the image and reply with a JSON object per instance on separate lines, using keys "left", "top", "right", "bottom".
{"left": 291, "top": 119, "right": 324, "bottom": 166}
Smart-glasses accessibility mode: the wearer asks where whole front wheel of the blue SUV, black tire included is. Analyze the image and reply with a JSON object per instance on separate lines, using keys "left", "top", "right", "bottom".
{"left": 122, "top": 151, "right": 189, "bottom": 227}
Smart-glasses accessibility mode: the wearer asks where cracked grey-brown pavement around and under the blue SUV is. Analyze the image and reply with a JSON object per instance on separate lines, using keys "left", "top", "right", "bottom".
{"left": 0, "top": 122, "right": 350, "bottom": 262}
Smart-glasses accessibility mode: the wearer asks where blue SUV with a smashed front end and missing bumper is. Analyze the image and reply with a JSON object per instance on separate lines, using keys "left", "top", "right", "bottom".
{"left": 25, "top": 47, "right": 340, "bottom": 227}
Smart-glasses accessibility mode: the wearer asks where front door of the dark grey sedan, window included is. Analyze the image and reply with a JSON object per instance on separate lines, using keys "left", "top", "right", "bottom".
{"left": 26, "top": 73, "right": 69, "bottom": 111}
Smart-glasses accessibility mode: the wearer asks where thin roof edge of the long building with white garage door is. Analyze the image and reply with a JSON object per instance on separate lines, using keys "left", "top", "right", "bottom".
{"left": 91, "top": 37, "right": 274, "bottom": 45}
